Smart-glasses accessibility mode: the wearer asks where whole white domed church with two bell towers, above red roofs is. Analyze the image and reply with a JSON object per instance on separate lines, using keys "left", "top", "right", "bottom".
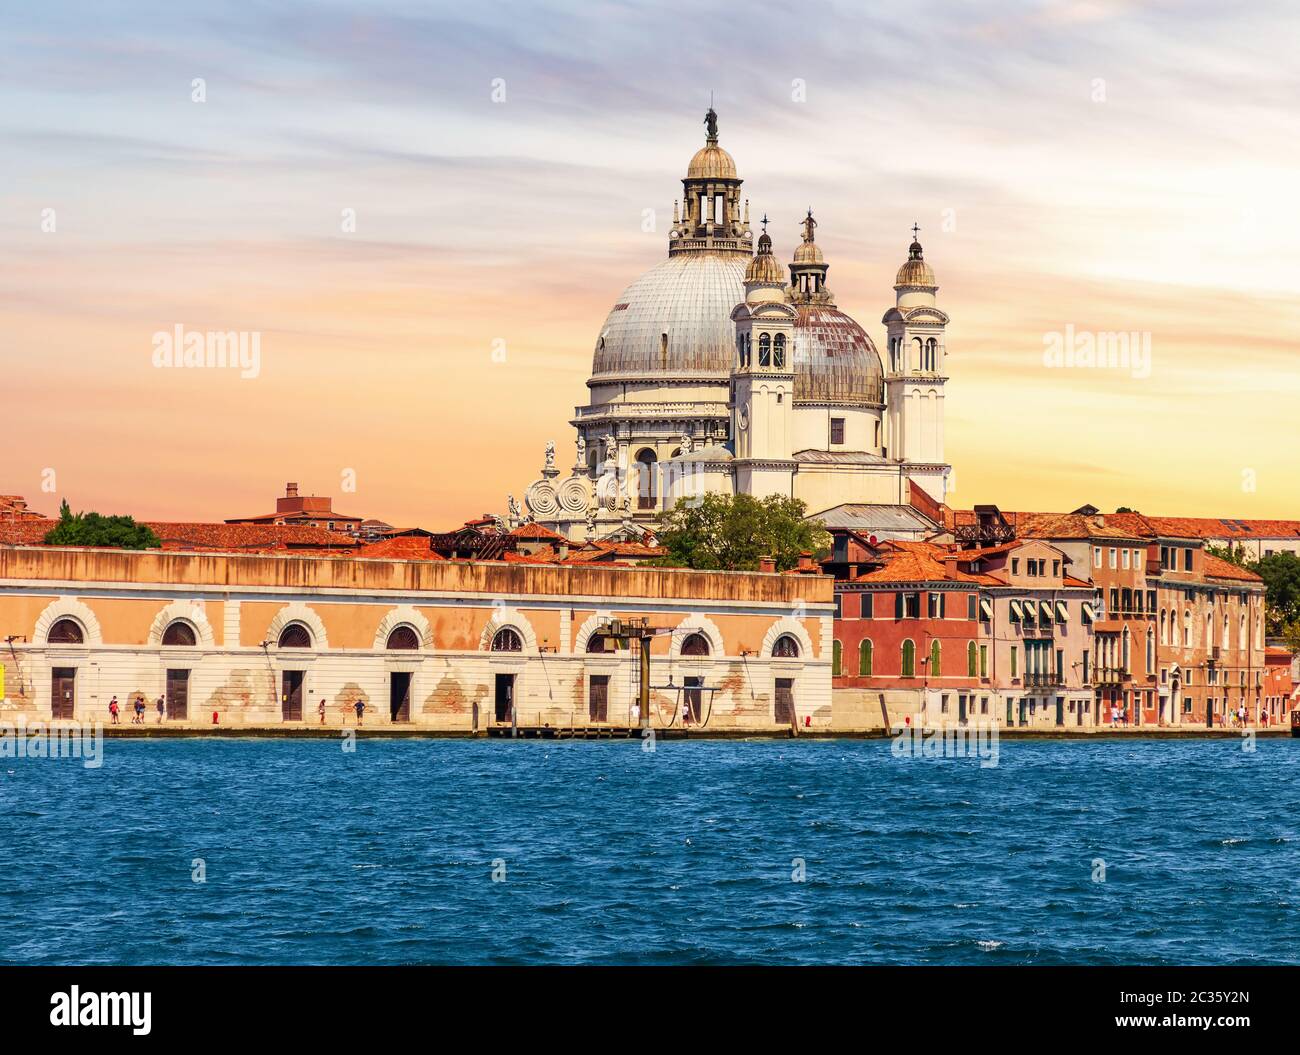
{"left": 520, "top": 109, "right": 950, "bottom": 539}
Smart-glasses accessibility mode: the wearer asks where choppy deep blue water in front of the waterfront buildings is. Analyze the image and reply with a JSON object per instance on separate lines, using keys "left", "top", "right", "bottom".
{"left": 0, "top": 739, "right": 1300, "bottom": 964}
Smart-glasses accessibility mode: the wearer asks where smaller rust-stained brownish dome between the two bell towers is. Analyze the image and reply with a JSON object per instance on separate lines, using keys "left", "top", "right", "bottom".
{"left": 792, "top": 304, "right": 884, "bottom": 405}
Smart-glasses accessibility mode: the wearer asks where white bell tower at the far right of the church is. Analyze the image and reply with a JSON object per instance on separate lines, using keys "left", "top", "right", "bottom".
{"left": 881, "top": 223, "right": 952, "bottom": 502}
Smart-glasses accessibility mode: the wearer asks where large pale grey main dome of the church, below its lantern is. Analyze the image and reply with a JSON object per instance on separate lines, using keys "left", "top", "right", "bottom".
{"left": 592, "top": 252, "right": 750, "bottom": 381}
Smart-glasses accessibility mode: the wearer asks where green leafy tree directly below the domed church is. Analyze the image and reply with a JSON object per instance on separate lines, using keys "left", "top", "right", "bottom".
{"left": 655, "top": 495, "right": 831, "bottom": 572}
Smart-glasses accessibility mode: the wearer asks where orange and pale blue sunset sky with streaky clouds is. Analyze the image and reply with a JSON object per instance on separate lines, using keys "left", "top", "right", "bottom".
{"left": 0, "top": 0, "right": 1300, "bottom": 528}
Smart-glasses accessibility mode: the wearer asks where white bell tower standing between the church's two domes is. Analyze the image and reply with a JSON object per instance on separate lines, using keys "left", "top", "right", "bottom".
{"left": 729, "top": 218, "right": 798, "bottom": 498}
